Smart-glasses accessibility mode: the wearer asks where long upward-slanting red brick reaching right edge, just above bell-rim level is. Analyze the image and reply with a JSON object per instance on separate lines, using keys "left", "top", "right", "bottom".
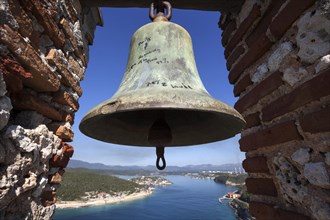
{"left": 262, "top": 68, "right": 330, "bottom": 121}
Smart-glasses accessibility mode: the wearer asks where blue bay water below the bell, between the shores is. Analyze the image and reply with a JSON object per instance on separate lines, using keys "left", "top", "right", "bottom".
{"left": 54, "top": 176, "right": 236, "bottom": 220}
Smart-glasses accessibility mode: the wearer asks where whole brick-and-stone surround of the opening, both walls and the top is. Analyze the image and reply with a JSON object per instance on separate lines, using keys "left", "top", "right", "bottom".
{"left": 0, "top": 0, "right": 330, "bottom": 220}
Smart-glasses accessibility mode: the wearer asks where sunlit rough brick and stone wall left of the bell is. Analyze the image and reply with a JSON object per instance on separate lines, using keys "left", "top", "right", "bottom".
{"left": 0, "top": 0, "right": 102, "bottom": 219}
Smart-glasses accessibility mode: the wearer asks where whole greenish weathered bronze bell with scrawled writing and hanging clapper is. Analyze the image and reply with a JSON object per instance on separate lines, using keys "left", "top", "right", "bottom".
{"left": 79, "top": 3, "right": 245, "bottom": 169}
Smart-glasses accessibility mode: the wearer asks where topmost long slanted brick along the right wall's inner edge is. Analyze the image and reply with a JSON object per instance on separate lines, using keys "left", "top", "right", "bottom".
{"left": 225, "top": 4, "right": 261, "bottom": 59}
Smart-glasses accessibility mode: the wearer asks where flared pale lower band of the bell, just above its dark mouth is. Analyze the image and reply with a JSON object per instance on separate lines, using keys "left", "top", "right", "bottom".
{"left": 82, "top": 88, "right": 246, "bottom": 123}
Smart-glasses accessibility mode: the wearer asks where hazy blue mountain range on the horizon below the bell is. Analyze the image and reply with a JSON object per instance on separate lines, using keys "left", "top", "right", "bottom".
{"left": 68, "top": 159, "right": 243, "bottom": 172}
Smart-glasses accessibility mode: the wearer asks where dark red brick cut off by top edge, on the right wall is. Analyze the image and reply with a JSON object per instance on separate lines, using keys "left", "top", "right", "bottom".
{"left": 269, "top": 0, "right": 315, "bottom": 40}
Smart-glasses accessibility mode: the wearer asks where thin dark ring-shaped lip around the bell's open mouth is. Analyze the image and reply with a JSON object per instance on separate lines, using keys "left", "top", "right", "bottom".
{"left": 79, "top": 107, "right": 246, "bottom": 147}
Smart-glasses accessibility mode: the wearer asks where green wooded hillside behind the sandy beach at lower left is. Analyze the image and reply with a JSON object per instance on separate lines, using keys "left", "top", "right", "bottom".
{"left": 57, "top": 169, "right": 143, "bottom": 201}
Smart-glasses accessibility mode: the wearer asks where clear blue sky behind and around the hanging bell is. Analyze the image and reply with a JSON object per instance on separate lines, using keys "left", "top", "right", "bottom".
{"left": 72, "top": 8, "right": 244, "bottom": 166}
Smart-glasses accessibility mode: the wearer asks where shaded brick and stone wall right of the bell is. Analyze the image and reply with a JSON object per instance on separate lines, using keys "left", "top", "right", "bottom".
{"left": 219, "top": 0, "right": 330, "bottom": 220}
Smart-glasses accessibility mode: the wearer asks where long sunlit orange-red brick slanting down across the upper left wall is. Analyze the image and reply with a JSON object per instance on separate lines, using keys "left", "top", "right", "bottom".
{"left": 0, "top": 25, "right": 60, "bottom": 92}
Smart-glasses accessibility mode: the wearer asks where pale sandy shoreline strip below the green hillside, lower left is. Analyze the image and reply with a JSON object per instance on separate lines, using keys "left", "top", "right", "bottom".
{"left": 55, "top": 190, "right": 153, "bottom": 209}
